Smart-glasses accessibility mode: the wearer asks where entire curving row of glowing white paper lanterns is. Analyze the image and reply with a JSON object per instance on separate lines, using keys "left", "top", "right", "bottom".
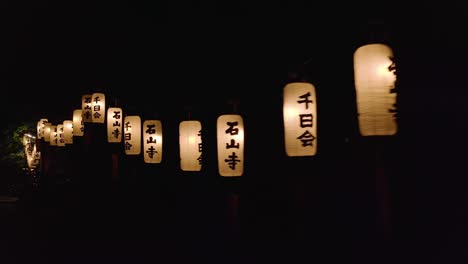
{"left": 33, "top": 43, "right": 397, "bottom": 176}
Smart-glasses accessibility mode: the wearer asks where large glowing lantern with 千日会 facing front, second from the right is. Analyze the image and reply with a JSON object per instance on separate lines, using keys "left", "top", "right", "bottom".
{"left": 283, "top": 82, "right": 317, "bottom": 157}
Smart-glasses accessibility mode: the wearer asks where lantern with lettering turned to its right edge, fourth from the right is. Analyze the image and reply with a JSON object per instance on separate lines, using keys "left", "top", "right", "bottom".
{"left": 179, "top": 120, "right": 202, "bottom": 171}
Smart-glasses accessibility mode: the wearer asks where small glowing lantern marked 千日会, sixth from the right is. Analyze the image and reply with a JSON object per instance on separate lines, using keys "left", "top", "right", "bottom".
{"left": 123, "top": 116, "right": 141, "bottom": 155}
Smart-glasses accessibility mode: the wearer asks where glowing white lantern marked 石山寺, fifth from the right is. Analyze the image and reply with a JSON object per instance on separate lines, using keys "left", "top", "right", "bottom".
{"left": 143, "top": 120, "right": 162, "bottom": 163}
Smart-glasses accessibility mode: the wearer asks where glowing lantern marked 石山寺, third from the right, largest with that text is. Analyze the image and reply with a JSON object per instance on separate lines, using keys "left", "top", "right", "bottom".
{"left": 216, "top": 115, "right": 244, "bottom": 177}
